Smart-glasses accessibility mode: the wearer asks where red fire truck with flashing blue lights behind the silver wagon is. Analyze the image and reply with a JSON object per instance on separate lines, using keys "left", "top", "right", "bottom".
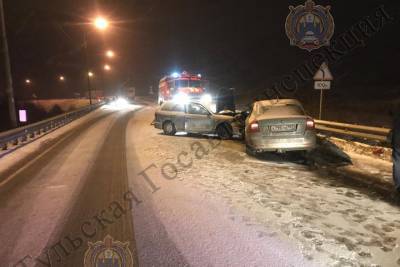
{"left": 158, "top": 71, "right": 207, "bottom": 104}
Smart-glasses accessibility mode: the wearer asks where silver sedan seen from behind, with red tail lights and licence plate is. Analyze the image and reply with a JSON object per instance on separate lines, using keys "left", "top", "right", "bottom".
{"left": 245, "top": 99, "right": 316, "bottom": 154}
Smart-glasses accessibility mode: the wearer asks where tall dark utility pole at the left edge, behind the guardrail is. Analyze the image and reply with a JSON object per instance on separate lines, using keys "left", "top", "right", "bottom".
{"left": 0, "top": 0, "right": 18, "bottom": 128}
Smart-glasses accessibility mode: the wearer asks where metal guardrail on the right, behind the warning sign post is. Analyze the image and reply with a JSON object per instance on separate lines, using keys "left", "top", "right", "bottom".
{"left": 315, "top": 120, "right": 391, "bottom": 142}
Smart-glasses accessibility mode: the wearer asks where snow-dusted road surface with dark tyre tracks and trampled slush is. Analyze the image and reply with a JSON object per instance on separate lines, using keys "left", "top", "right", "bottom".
{"left": 0, "top": 103, "right": 400, "bottom": 266}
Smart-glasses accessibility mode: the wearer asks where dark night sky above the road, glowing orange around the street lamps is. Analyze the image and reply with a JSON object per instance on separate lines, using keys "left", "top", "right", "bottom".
{"left": 1, "top": 0, "right": 400, "bottom": 101}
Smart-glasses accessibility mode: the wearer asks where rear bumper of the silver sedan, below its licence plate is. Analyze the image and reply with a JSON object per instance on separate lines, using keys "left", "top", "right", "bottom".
{"left": 246, "top": 133, "right": 316, "bottom": 152}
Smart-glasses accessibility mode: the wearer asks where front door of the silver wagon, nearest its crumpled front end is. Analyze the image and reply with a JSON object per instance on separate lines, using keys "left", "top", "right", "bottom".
{"left": 185, "top": 103, "right": 214, "bottom": 133}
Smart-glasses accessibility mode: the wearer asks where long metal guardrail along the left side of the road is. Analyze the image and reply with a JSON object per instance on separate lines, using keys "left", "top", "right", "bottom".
{"left": 0, "top": 103, "right": 103, "bottom": 150}
